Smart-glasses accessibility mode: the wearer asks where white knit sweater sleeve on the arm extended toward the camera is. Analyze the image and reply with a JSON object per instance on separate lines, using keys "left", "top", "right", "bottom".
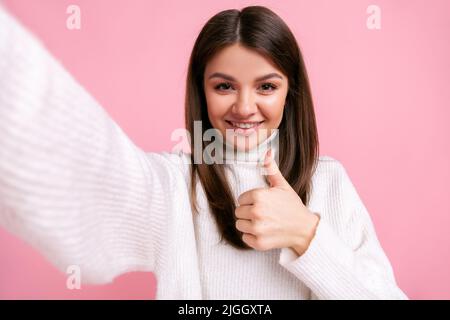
{"left": 0, "top": 6, "right": 181, "bottom": 283}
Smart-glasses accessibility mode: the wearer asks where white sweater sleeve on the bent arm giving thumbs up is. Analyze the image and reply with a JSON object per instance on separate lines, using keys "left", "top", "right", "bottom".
{"left": 280, "top": 160, "right": 407, "bottom": 300}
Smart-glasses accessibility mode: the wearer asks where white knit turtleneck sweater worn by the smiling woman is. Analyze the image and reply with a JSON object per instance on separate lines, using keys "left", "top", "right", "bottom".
{"left": 0, "top": 8, "right": 407, "bottom": 299}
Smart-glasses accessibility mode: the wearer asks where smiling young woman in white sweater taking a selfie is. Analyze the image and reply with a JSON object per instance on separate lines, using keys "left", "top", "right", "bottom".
{"left": 0, "top": 6, "right": 406, "bottom": 299}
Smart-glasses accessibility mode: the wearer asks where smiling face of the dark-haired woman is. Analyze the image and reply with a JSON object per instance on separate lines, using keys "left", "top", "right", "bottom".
{"left": 204, "top": 44, "right": 288, "bottom": 151}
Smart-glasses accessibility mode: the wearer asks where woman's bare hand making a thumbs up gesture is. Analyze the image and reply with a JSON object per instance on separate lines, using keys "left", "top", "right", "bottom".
{"left": 235, "top": 149, "right": 319, "bottom": 256}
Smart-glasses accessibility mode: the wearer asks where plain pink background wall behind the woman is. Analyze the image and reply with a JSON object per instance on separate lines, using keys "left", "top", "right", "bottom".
{"left": 0, "top": 0, "right": 450, "bottom": 299}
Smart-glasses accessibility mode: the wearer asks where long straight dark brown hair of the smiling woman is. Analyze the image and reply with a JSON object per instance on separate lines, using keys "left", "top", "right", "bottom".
{"left": 185, "top": 6, "right": 319, "bottom": 249}
